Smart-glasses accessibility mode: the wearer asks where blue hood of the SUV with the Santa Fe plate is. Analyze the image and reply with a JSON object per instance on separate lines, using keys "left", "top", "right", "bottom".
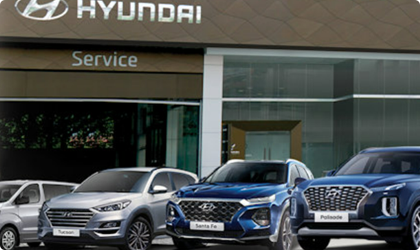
{"left": 178, "top": 183, "right": 286, "bottom": 199}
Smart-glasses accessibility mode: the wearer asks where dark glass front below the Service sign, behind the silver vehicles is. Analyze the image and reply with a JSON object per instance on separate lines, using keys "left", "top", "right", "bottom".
{"left": 0, "top": 102, "right": 200, "bottom": 181}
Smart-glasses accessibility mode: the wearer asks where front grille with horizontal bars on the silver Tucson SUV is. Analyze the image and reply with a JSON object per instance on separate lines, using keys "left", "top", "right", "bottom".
{"left": 47, "top": 209, "right": 93, "bottom": 227}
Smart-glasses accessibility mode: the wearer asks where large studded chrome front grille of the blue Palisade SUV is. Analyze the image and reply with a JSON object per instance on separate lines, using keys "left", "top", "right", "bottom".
{"left": 304, "top": 186, "right": 368, "bottom": 211}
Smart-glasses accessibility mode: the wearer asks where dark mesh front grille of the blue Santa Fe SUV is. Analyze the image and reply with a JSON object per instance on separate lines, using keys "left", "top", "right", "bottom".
{"left": 179, "top": 200, "right": 242, "bottom": 222}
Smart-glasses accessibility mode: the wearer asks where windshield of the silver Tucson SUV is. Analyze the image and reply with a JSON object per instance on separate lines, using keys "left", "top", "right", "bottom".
{"left": 74, "top": 171, "right": 148, "bottom": 193}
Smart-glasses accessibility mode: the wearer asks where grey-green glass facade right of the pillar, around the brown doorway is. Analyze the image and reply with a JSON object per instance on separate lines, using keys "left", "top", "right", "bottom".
{"left": 223, "top": 56, "right": 420, "bottom": 177}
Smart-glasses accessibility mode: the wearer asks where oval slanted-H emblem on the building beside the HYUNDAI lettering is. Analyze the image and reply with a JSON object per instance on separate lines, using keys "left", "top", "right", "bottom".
{"left": 15, "top": 0, "right": 69, "bottom": 21}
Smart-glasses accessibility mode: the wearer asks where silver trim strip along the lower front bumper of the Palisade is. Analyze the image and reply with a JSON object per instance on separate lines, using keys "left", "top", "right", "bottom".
{"left": 298, "top": 227, "right": 379, "bottom": 237}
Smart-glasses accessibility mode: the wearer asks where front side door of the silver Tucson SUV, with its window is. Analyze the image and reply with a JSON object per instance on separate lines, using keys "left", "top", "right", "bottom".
{"left": 149, "top": 172, "right": 174, "bottom": 231}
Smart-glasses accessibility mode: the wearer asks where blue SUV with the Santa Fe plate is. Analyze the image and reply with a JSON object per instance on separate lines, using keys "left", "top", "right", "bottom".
{"left": 166, "top": 160, "right": 313, "bottom": 250}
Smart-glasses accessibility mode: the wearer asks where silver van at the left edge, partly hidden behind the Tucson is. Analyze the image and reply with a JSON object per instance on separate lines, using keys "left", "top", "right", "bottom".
{"left": 0, "top": 180, "right": 77, "bottom": 250}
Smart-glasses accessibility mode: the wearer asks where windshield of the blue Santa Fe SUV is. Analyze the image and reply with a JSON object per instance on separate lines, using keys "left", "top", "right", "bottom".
{"left": 205, "top": 162, "right": 287, "bottom": 184}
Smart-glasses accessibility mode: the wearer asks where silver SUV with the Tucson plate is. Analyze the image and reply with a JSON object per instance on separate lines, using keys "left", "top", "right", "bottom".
{"left": 38, "top": 167, "right": 198, "bottom": 250}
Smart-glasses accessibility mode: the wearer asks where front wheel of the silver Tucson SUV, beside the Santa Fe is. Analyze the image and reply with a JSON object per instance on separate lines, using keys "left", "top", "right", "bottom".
{"left": 119, "top": 217, "right": 153, "bottom": 250}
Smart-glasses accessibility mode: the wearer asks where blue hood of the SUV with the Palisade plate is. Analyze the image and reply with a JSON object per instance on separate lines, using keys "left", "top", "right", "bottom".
{"left": 299, "top": 174, "right": 419, "bottom": 188}
